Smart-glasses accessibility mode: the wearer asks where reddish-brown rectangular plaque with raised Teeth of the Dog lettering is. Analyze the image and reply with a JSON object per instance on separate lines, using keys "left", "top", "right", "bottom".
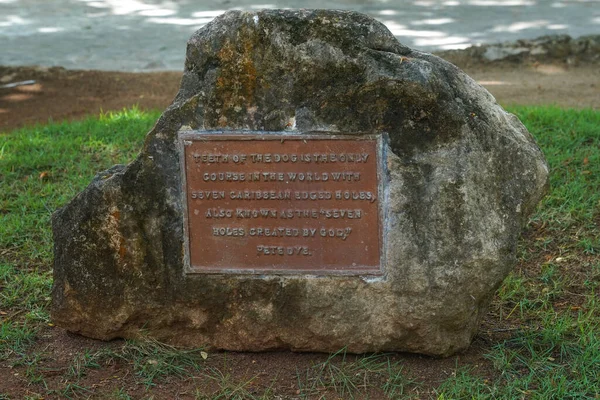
{"left": 180, "top": 132, "right": 383, "bottom": 275}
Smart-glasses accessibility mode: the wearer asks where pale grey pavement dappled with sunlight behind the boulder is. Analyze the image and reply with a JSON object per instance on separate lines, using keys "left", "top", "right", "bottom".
{"left": 0, "top": 0, "right": 600, "bottom": 71}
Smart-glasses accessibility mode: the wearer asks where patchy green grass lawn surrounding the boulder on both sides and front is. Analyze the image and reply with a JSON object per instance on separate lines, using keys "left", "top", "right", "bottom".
{"left": 0, "top": 107, "right": 600, "bottom": 399}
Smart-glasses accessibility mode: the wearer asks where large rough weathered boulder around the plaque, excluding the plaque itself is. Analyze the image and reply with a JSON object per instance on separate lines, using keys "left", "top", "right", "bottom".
{"left": 52, "top": 10, "right": 547, "bottom": 356}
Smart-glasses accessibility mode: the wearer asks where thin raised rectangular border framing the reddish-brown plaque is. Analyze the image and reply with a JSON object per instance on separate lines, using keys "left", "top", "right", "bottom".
{"left": 176, "top": 129, "right": 389, "bottom": 276}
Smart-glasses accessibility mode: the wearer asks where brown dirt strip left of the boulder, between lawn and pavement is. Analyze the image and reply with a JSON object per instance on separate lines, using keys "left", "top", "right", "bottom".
{"left": 0, "top": 67, "right": 181, "bottom": 131}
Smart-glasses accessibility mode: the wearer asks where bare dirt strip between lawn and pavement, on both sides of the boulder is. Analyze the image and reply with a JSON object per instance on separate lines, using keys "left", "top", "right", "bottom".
{"left": 0, "top": 62, "right": 600, "bottom": 131}
